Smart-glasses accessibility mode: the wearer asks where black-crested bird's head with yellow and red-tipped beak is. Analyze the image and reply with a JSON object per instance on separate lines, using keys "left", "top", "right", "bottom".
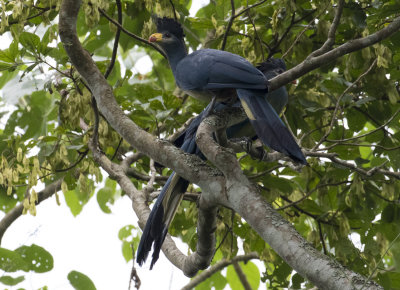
{"left": 149, "top": 17, "right": 185, "bottom": 53}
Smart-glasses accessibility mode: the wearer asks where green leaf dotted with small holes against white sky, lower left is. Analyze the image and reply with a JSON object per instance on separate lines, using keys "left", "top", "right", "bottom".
{"left": 15, "top": 244, "right": 54, "bottom": 273}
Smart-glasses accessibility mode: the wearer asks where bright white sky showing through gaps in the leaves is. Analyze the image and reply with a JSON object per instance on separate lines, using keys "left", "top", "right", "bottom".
{"left": 0, "top": 0, "right": 209, "bottom": 290}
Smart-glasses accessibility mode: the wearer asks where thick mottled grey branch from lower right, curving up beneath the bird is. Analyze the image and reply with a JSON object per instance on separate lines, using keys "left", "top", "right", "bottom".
{"left": 197, "top": 110, "right": 382, "bottom": 289}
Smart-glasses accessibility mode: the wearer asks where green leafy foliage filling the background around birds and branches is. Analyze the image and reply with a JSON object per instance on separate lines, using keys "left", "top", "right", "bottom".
{"left": 0, "top": 0, "right": 400, "bottom": 289}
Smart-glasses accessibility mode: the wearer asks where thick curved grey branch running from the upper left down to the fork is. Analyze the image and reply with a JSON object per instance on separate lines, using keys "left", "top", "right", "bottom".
{"left": 59, "top": 0, "right": 215, "bottom": 186}
